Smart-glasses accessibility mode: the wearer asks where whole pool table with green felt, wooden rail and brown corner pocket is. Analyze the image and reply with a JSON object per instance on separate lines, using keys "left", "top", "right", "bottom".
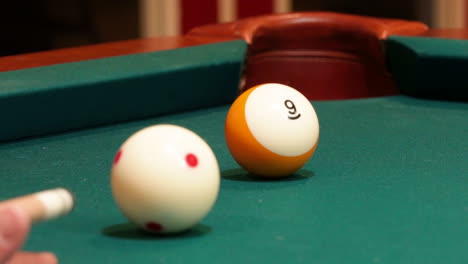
{"left": 0, "top": 13, "right": 468, "bottom": 264}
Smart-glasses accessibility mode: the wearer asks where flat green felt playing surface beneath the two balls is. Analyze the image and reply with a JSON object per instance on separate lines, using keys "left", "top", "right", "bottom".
{"left": 0, "top": 96, "right": 468, "bottom": 264}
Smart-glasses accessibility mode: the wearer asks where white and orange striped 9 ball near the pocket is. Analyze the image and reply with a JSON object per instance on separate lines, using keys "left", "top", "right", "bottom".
{"left": 225, "top": 83, "right": 319, "bottom": 178}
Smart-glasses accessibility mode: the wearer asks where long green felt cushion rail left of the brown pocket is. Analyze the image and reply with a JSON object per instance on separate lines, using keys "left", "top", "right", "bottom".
{"left": 0, "top": 41, "right": 246, "bottom": 141}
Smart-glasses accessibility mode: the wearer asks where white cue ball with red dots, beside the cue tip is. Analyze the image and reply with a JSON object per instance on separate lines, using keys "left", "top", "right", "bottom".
{"left": 111, "top": 124, "right": 220, "bottom": 233}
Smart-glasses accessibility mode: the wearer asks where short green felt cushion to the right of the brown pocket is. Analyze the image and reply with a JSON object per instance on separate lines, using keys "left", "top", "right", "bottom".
{"left": 385, "top": 36, "right": 468, "bottom": 101}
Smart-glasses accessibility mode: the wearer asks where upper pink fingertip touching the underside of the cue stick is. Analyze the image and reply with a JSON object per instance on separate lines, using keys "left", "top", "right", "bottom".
{"left": 0, "top": 205, "right": 31, "bottom": 263}
